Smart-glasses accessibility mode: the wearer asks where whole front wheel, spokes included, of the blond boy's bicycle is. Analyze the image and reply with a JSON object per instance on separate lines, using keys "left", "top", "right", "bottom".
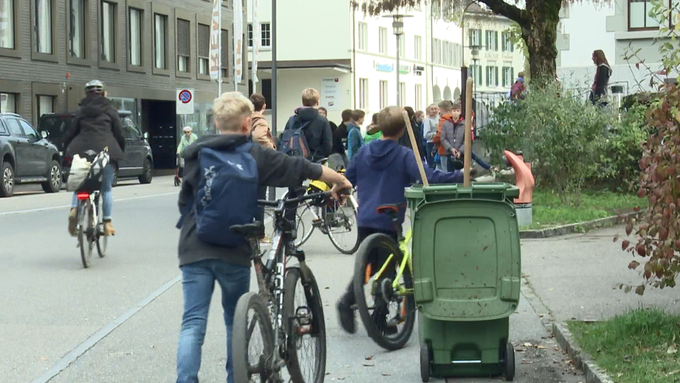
{"left": 283, "top": 267, "right": 326, "bottom": 383}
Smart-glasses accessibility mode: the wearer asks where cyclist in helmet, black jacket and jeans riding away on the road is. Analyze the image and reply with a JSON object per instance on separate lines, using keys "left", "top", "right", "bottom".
{"left": 64, "top": 80, "right": 125, "bottom": 236}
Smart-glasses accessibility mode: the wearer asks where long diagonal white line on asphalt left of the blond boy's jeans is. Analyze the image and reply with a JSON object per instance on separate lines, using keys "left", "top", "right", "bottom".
{"left": 31, "top": 275, "right": 182, "bottom": 383}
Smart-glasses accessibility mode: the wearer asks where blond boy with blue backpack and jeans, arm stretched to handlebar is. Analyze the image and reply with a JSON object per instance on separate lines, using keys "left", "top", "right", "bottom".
{"left": 177, "top": 92, "right": 352, "bottom": 383}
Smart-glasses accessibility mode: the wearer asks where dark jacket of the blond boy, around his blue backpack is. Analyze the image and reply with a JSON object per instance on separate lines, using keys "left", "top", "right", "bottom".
{"left": 178, "top": 134, "right": 322, "bottom": 266}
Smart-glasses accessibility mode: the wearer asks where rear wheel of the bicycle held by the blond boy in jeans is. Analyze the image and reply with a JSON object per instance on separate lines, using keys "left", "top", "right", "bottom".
{"left": 231, "top": 293, "right": 274, "bottom": 383}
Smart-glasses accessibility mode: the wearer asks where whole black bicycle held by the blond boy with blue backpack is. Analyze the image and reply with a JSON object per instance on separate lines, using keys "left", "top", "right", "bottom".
{"left": 230, "top": 192, "right": 346, "bottom": 383}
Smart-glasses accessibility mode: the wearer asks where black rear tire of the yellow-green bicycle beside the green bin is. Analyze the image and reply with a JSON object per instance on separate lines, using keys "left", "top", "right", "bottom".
{"left": 352, "top": 233, "right": 416, "bottom": 351}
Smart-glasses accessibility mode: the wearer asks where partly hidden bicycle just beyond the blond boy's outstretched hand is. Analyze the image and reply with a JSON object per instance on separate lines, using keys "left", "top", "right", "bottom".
{"left": 283, "top": 158, "right": 359, "bottom": 254}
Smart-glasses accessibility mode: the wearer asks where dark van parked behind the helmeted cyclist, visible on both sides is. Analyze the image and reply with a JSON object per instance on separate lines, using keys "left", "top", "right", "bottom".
{"left": 38, "top": 111, "right": 153, "bottom": 185}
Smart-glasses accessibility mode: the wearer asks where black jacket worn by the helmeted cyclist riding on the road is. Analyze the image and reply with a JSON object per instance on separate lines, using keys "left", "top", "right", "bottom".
{"left": 64, "top": 96, "right": 125, "bottom": 161}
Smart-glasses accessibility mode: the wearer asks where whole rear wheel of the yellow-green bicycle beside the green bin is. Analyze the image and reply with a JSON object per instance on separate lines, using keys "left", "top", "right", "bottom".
{"left": 353, "top": 233, "right": 416, "bottom": 351}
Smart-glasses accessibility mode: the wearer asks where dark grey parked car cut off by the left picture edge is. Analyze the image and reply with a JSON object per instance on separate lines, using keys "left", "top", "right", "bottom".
{"left": 0, "top": 113, "right": 62, "bottom": 197}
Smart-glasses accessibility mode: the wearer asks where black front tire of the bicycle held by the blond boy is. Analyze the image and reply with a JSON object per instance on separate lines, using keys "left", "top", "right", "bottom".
{"left": 283, "top": 266, "right": 327, "bottom": 383}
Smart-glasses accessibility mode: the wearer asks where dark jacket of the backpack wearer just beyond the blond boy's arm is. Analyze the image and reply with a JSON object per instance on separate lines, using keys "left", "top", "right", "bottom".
{"left": 285, "top": 107, "right": 333, "bottom": 161}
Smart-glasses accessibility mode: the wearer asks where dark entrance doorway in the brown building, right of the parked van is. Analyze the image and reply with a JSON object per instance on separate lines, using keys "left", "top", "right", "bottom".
{"left": 142, "top": 100, "right": 177, "bottom": 169}
